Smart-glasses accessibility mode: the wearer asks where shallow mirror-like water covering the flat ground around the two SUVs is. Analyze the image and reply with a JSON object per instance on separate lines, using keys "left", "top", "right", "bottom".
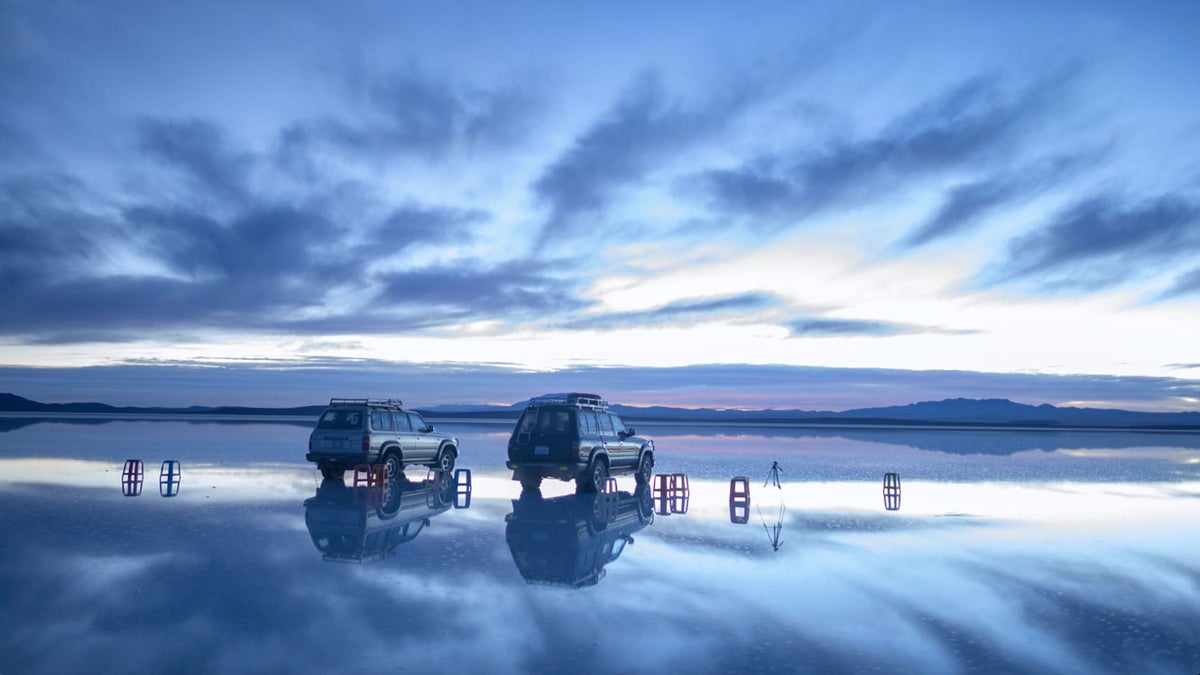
{"left": 0, "top": 419, "right": 1200, "bottom": 673}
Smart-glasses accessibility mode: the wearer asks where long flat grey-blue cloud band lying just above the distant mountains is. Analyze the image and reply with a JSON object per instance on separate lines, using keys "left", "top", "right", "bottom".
{"left": 9, "top": 357, "right": 1200, "bottom": 411}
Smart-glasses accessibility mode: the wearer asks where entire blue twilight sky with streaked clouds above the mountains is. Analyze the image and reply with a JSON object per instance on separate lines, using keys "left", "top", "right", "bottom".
{"left": 0, "top": 0, "right": 1200, "bottom": 403}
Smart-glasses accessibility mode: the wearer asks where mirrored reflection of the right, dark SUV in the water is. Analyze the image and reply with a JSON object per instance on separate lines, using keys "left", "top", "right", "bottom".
{"left": 504, "top": 485, "right": 654, "bottom": 589}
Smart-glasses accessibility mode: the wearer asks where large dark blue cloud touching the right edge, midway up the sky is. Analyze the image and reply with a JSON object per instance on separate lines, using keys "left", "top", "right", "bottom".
{"left": 997, "top": 195, "right": 1200, "bottom": 289}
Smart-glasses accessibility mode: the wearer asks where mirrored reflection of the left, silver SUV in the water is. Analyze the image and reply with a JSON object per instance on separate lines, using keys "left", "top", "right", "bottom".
{"left": 304, "top": 472, "right": 455, "bottom": 562}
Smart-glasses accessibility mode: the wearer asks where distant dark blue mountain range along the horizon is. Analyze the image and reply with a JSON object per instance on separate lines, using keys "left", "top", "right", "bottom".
{"left": 0, "top": 394, "right": 1200, "bottom": 431}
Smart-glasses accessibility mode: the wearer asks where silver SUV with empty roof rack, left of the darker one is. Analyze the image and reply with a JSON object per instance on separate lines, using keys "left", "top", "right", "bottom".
{"left": 305, "top": 399, "right": 458, "bottom": 480}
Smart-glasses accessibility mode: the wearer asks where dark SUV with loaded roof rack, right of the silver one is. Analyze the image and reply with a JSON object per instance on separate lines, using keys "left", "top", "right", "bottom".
{"left": 508, "top": 393, "right": 654, "bottom": 492}
